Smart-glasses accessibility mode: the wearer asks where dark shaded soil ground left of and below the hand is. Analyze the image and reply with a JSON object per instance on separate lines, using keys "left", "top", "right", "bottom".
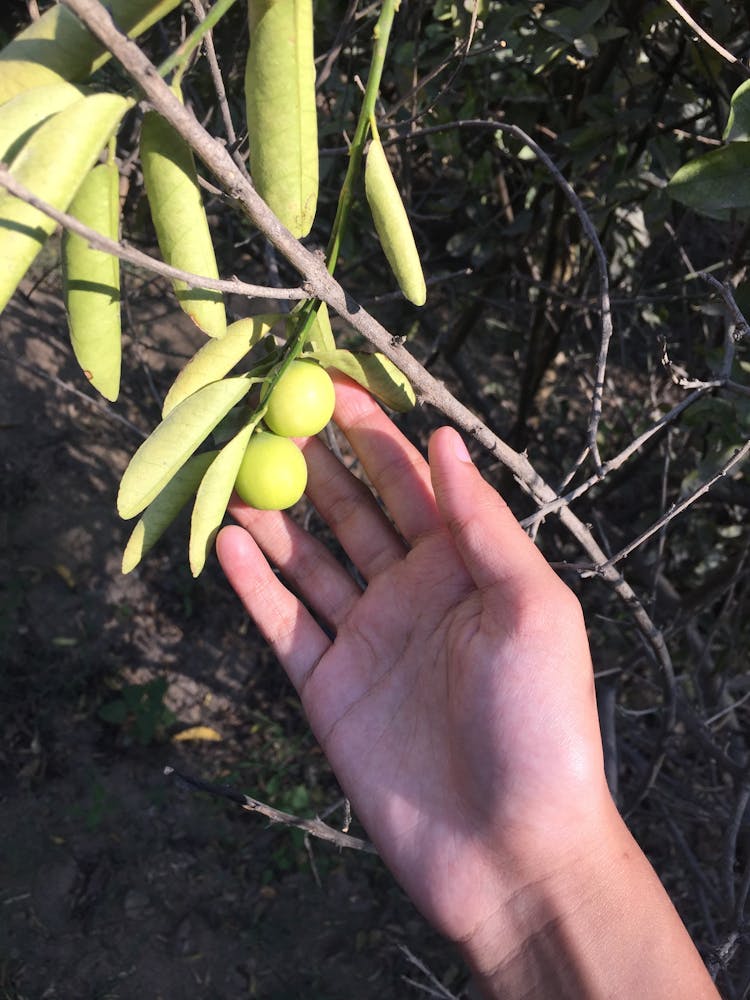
{"left": 0, "top": 288, "right": 466, "bottom": 1000}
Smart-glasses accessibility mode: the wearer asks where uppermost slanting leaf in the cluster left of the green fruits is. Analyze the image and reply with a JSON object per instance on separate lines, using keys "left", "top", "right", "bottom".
{"left": 162, "top": 313, "right": 281, "bottom": 417}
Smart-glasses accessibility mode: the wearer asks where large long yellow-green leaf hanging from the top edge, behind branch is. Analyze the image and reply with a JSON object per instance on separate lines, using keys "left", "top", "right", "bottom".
{"left": 245, "top": 0, "right": 318, "bottom": 238}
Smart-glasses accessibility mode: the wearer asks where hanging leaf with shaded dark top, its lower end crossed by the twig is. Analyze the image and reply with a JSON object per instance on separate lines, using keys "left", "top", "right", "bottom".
{"left": 141, "top": 101, "right": 227, "bottom": 337}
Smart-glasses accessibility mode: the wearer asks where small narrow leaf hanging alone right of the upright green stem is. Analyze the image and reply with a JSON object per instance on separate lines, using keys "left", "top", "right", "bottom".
{"left": 365, "top": 128, "right": 427, "bottom": 306}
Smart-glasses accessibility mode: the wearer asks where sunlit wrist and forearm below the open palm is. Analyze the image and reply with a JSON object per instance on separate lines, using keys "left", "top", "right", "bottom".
{"left": 464, "top": 807, "right": 719, "bottom": 1000}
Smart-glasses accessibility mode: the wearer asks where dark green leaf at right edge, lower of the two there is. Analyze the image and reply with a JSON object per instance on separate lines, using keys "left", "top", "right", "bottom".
{"left": 667, "top": 142, "right": 750, "bottom": 219}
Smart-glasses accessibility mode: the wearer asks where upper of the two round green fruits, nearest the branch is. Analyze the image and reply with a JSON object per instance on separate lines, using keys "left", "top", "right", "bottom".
{"left": 263, "top": 361, "right": 336, "bottom": 437}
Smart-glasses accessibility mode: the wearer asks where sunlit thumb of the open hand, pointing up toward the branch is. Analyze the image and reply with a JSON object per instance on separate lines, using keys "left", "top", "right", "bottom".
{"left": 429, "top": 427, "right": 557, "bottom": 589}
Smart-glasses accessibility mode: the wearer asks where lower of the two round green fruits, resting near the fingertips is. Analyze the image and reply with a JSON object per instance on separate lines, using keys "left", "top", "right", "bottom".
{"left": 234, "top": 431, "right": 307, "bottom": 510}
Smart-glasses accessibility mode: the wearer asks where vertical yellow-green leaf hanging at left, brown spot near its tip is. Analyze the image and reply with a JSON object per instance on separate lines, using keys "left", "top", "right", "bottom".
{"left": 62, "top": 160, "right": 122, "bottom": 401}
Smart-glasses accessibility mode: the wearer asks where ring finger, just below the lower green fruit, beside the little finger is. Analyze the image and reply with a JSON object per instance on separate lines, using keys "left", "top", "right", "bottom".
{"left": 229, "top": 496, "right": 362, "bottom": 629}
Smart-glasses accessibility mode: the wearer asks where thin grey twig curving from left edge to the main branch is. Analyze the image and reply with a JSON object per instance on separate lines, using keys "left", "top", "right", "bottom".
{"left": 0, "top": 163, "right": 308, "bottom": 299}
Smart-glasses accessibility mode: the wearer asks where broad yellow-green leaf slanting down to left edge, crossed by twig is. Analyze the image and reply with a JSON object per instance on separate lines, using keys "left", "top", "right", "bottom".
{"left": 0, "top": 94, "right": 133, "bottom": 311}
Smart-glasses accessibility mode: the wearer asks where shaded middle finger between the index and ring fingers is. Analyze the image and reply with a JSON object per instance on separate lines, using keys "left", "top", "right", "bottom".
{"left": 303, "top": 438, "right": 407, "bottom": 580}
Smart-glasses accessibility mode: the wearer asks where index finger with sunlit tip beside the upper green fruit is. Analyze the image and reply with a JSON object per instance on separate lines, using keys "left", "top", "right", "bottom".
{"left": 333, "top": 374, "right": 441, "bottom": 543}
